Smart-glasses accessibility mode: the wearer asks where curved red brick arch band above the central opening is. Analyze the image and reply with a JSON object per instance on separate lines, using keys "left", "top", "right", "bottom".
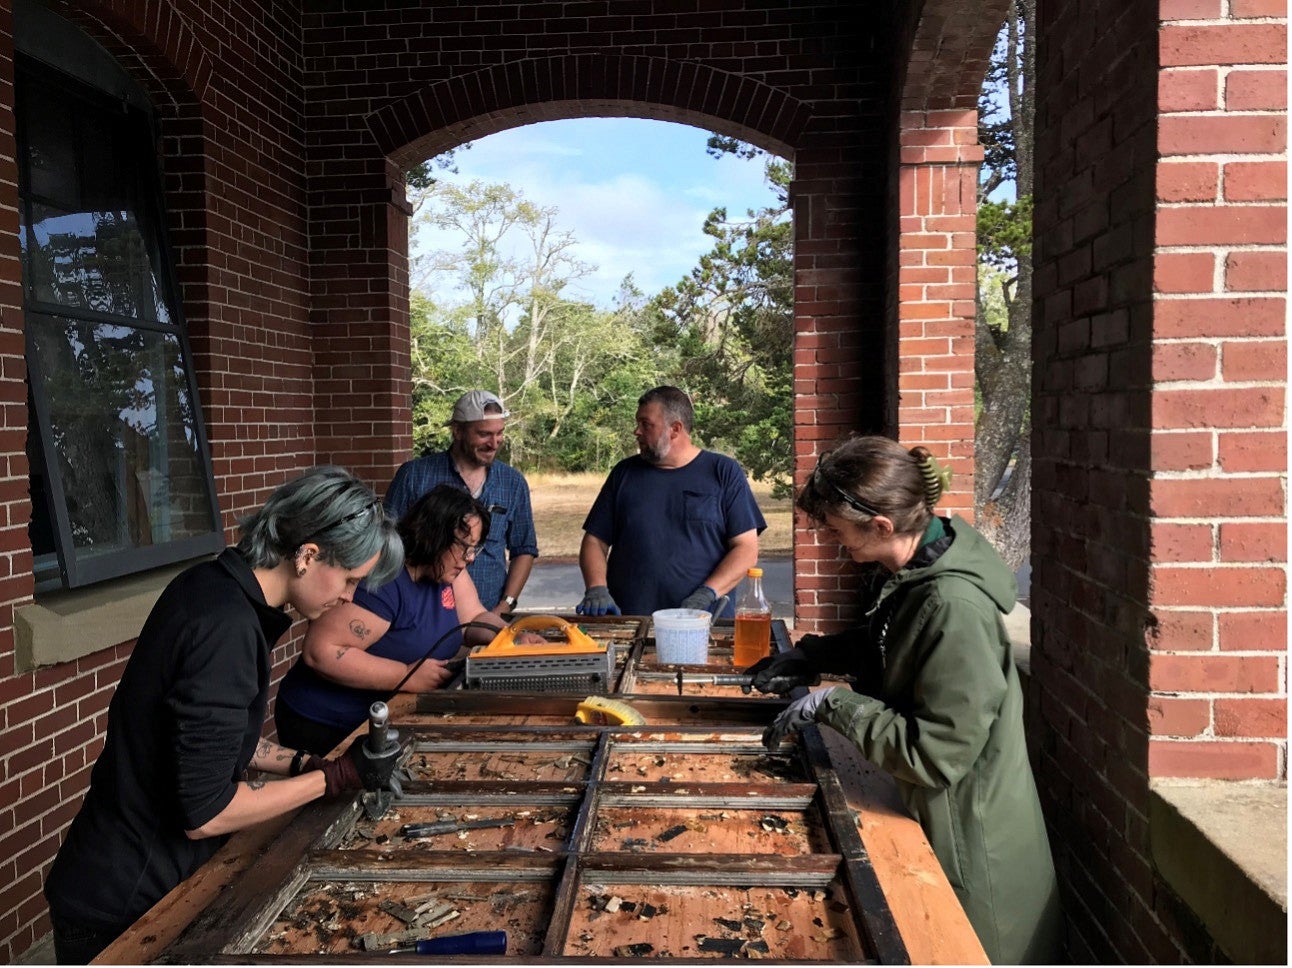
{"left": 367, "top": 54, "right": 811, "bottom": 168}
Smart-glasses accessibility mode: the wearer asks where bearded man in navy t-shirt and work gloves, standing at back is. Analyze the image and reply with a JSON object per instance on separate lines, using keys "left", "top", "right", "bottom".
{"left": 576, "top": 386, "right": 767, "bottom": 615}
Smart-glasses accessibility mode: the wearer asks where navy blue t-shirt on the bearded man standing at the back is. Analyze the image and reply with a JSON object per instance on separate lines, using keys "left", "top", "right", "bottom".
{"left": 583, "top": 450, "right": 767, "bottom": 615}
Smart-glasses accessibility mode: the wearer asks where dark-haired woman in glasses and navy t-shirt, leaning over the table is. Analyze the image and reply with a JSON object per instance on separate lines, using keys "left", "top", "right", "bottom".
{"left": 274, "top": 485, "right": 541, "bottom": 753}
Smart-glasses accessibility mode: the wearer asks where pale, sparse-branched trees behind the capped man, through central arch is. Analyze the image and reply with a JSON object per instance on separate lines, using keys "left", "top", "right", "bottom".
{"left": 412, "top": 181, "right": 656, "bottom": 470}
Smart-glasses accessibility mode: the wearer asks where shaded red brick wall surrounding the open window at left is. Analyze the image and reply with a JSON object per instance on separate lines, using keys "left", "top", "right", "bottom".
{"left": 0, "top": 0, "right": 315, "bottom": 960}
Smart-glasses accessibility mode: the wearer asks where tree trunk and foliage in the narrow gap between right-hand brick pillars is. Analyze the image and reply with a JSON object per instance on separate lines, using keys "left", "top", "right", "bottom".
{"left": 974, "top": 0, "right": 1036, "bottom": 567}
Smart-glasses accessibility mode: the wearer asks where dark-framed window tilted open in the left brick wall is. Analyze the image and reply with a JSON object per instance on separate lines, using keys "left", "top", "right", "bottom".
{"left": 16, "top": 58, "right": 224, "bottom": 591}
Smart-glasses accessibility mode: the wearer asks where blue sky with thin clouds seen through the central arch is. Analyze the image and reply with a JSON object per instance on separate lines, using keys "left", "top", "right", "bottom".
{"left": 408, "top": 118, "right": 775, "bottom": 308}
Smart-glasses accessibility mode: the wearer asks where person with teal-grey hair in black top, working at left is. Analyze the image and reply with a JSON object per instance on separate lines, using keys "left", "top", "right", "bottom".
{"left": 45, "top": 468, "right": 403, "bottom": 964}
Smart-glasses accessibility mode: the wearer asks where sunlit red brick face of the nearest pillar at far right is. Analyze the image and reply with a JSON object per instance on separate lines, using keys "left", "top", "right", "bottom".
{"left": 1147, "top": 0, "right": 1287, "bottom": 779}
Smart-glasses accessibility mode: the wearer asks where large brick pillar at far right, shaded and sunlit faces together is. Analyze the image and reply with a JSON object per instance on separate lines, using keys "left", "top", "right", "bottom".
{"left": 1032, "top": 0, "right": 1287, "bottom": 963}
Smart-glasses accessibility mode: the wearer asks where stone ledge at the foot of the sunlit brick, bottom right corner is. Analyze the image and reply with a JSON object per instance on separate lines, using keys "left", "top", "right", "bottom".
{"left": 1149, "top": 779, "right": 1288, "bottom": 964}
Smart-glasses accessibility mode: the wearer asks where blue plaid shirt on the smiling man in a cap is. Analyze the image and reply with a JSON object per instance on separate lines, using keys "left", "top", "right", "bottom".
{"left": 385, "top": 451, "right": 539, "bottom": 609}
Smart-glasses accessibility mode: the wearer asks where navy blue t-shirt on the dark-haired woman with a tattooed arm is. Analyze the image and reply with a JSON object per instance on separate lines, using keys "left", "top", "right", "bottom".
{"left": 278, "top": 569, "right": 463, "bottom": 729}
